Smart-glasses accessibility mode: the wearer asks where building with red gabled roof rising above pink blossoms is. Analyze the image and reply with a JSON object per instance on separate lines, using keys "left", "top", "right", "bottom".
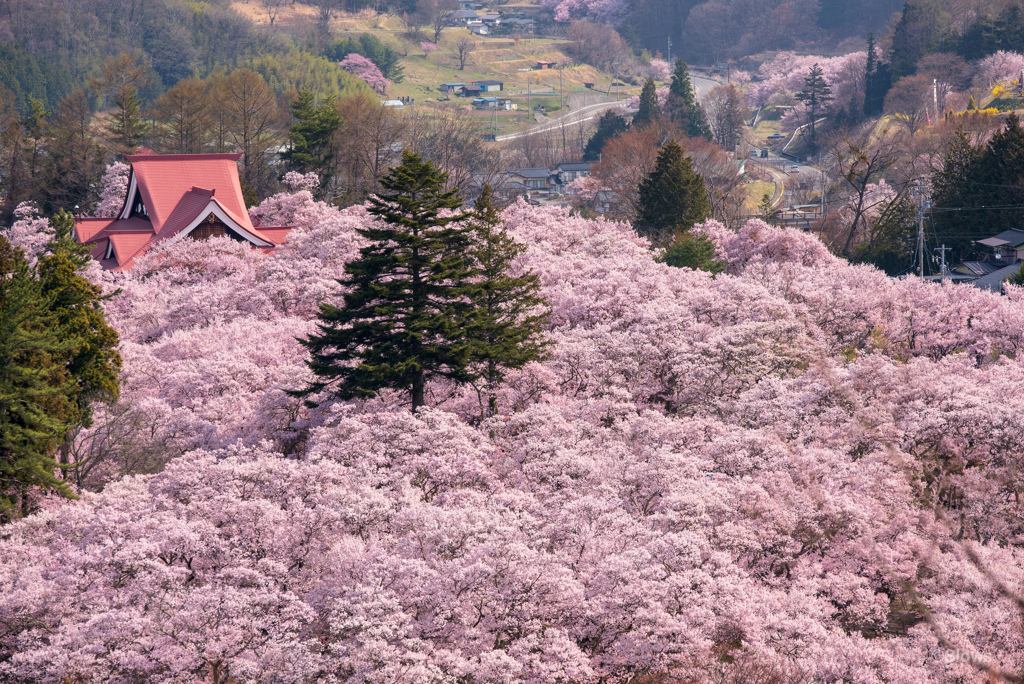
{"left": 75, "top": 154, "right": 292, "bottom": 270}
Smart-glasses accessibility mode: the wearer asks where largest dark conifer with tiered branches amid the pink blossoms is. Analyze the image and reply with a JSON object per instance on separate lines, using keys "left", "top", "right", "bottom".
{"left": 295, "top": 151, "right": 479, "bottom": 411}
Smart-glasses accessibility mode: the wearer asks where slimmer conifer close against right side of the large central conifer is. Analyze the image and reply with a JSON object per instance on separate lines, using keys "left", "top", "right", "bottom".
{"left": 468, "top": 185, "right": 549, "bottom": 418}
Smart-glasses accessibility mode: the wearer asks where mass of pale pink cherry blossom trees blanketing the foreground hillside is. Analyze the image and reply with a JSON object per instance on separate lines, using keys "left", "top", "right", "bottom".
{"left": 0, "top": 177, "right": 1024, "bottom": 684}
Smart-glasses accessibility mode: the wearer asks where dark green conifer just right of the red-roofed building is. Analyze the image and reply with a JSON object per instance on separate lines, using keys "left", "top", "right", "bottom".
{"left": 282, "top": 88, "right": 341, "bottom": 199}
